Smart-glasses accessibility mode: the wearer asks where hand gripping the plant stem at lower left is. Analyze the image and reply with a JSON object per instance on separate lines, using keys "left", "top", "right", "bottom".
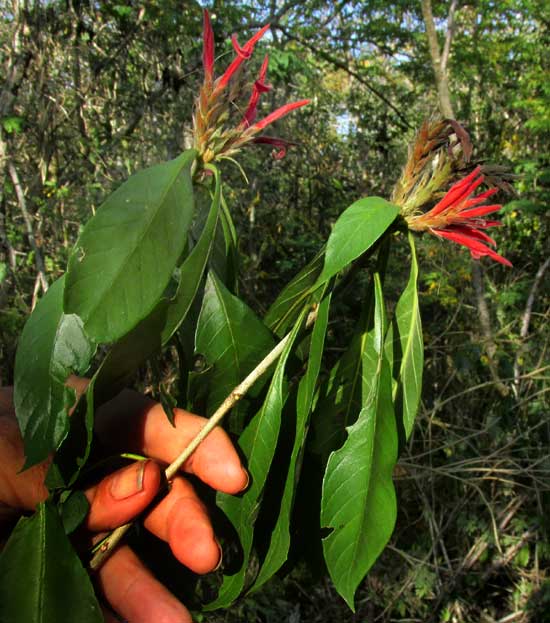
{"left": 0, "top": 388, "right": 248, "bottom": 623}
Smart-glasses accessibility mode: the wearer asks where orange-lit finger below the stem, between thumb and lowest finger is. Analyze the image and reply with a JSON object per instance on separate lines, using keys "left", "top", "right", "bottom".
{"left": 144, "top": 477, "right": 222, "bottom": 573}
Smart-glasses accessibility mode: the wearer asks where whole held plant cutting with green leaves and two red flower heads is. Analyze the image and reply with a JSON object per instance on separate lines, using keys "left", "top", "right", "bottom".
{"left": 0, "top": 11, "right": 509, "bottom": 623}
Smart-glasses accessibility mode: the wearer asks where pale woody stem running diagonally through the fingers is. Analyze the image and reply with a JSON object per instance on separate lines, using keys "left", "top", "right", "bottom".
{"left": 90, "top": 307, "right": 317, "bottom": 571}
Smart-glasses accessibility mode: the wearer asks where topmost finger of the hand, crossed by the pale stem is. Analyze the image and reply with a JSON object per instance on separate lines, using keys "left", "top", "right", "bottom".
{"left": 98, "top": 391, "right": 248, "bottom": 493}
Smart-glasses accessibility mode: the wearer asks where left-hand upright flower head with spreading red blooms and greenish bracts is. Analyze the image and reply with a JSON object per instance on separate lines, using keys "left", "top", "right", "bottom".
{"left": 194, "top": 10, "right": 309, "bottom": 162}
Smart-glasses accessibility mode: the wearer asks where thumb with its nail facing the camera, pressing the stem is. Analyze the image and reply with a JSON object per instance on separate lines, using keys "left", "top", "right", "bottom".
{"left": 85, "top": 461, "right": 161, "bottom": 532}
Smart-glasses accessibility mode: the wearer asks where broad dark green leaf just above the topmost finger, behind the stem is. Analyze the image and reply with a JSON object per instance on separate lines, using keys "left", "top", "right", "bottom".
{"left": 195, "top": 272, "right": 274, "bottom": 414}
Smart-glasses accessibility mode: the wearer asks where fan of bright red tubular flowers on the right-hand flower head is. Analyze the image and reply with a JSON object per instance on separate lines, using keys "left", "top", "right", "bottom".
{"left": 406, "top": 167, "right": 512, "bottom": 266}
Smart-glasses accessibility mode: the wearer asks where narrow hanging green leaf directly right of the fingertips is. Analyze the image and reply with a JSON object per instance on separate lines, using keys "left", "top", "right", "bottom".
{"left": 206, "top": 310, "right": 307, "bottom": 610}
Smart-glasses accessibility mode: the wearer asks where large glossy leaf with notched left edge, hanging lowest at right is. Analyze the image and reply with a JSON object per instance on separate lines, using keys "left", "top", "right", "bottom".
{"left": 321, "top": 274, "right": 397, "bottom": 610}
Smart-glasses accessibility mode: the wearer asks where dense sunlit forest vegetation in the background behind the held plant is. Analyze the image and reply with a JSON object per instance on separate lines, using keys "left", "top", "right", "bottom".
{"left": 0, "top": 0, "right": 550, "bottom": 623}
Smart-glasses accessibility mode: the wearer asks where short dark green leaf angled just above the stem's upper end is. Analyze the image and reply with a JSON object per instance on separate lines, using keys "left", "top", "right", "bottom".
{"left": 264, "top": 252, "right": 323, "bottom": 337}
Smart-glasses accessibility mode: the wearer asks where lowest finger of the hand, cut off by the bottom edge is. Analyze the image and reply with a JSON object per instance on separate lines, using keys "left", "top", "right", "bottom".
{"left": 97, "top": 545, "right": 192, "bottom": 623}
